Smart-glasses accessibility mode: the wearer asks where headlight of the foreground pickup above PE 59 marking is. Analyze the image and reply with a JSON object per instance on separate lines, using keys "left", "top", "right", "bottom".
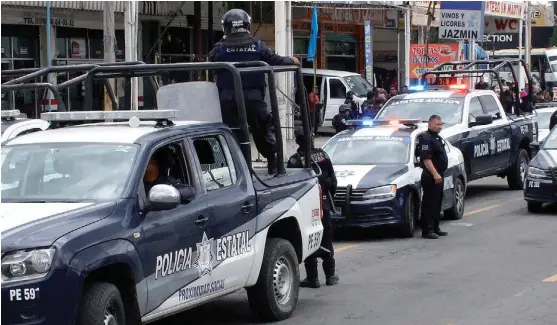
{"left": 2, "top": 248, "right": 55, "bottom": 282}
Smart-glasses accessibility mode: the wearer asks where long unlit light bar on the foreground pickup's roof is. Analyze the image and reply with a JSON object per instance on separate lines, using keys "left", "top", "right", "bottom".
{"left": 41, "top": 110, "right": 178, "bottom": 122}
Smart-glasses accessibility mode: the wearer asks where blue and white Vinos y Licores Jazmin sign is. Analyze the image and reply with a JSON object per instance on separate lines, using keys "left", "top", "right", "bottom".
{"left": 439, "top": 1, "right": 484, "bottom": 40}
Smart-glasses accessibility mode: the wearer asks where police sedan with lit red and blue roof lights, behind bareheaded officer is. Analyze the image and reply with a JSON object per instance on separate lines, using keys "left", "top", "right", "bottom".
{"left": 323, "top": 119, "right": 467, "bottom": 237}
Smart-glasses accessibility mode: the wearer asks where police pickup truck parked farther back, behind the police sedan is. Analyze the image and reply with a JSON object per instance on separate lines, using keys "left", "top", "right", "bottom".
{"left": 376, "top": 84, "right": 537, "bottom": 190}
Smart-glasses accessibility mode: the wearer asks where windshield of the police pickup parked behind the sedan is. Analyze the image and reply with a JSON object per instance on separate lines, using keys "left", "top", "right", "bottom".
{"left": 376, "top": 98, "right": 464, "bottom": 124}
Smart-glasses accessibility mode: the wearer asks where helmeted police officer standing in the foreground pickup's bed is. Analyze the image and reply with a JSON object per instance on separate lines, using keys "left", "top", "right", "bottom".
{"left": 209, "top": 9, "right": 300, "bottom": 174}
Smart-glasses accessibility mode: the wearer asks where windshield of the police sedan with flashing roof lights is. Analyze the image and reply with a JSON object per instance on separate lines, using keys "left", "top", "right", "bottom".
{"left": 323, "top": 136, "right": 410, "bottom": 165}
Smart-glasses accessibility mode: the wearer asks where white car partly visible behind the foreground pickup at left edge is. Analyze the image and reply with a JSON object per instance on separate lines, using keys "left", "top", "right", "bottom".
{"left": 1, "top": 109, "right": 50, "bottom": 143}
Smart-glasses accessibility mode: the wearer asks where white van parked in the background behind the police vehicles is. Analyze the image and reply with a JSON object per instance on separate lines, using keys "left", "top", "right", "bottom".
{"left": 302, "top": 69, "right": 377, "bottom": 127}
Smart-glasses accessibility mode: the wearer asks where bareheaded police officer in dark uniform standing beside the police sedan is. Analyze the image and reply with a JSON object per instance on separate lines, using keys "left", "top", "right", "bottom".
{"left": 418, "top": 115, "right": 449, "bottom": 239}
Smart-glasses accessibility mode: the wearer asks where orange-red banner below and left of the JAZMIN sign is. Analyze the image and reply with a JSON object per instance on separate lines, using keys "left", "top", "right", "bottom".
{"left": 410, "top": 43, "right": 459, "bottom": 79}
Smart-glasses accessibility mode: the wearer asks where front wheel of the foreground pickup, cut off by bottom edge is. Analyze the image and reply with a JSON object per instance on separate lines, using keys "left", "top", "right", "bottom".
{"left": 77, "top": 282, "right": 126, "bottom": 325}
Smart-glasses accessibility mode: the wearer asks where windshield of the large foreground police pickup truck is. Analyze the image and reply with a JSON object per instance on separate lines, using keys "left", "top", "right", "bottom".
{"left": 1, "top": 143, "right": 138, "bottom": 202}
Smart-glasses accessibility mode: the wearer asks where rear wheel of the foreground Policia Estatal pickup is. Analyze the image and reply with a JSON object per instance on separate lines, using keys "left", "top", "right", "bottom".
{"left": 247, "top": 238, "right": 300, "bottom": 322}
